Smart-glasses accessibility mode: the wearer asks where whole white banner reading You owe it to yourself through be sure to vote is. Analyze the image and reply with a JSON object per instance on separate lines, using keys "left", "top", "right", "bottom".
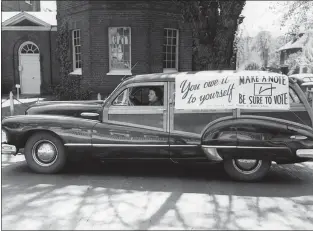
{"left": 175, "top": 72, "right": 289, "bottom": 110}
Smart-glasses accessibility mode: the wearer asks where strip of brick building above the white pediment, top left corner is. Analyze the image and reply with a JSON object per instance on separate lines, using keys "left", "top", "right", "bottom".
{"left": 1, "top": 0, "right": 40, "bottom": 12}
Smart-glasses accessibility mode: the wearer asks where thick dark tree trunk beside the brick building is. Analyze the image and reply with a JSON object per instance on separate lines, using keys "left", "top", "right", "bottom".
{"left": 193, "top": 1, "right": 245, "bottom": 71}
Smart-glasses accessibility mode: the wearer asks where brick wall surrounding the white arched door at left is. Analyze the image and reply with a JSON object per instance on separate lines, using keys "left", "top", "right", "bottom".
{"left": 1, "top": 31, "right": 56, "bottom": 93}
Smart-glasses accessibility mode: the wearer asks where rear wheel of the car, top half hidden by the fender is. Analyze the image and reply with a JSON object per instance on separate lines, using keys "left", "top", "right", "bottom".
{"left": 224, "top": 159, "right": 272, "bottom": 181}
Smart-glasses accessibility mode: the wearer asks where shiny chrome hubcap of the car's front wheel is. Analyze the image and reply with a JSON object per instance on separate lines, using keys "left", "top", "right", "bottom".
{"left": 32, "top": 140, "right": 58, "bottom": 166}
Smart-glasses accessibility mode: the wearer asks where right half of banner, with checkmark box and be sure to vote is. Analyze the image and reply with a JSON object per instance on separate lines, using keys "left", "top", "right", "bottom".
{"left": 236, "top": 74, "right": 290, "bottom": 110}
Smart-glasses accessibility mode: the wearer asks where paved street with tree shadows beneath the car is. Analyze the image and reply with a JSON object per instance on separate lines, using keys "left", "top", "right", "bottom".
{"left": 2, "top": 155, "right": 313, "bottom": 230}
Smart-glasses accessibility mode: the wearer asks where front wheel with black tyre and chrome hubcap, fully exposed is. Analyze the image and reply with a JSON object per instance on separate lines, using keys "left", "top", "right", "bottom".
{"left": 24, "top": 132, "right": 66, "bottom": 174}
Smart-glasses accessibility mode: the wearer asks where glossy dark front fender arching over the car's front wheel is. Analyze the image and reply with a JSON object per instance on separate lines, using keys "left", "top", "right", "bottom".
{"left": 2, "top": 115, "right": 99, "bottom": 148}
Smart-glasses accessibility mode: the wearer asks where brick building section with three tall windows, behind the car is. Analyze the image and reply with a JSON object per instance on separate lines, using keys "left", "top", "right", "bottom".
{"left": 57, "top": 0, "right": 192, "bottom": 95}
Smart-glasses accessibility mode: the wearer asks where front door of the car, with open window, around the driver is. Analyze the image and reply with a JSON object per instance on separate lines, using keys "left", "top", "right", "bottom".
{"left": 92, "top": 82, "right": 169, "bottom": 159}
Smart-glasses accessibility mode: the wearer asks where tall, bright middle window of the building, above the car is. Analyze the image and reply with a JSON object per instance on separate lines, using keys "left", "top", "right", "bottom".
{"left": 108, "top": 27, "right": 131, "bottom": 75}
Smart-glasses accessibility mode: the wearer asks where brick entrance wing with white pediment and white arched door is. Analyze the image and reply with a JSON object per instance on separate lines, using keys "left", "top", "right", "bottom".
{"left": 1, "top": 12, "right": 59, "bottom": 95}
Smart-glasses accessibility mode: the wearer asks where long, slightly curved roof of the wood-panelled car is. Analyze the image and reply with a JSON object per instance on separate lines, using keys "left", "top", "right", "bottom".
{"left": 124, "top": 70, "right": 290, "bottom": 84}
